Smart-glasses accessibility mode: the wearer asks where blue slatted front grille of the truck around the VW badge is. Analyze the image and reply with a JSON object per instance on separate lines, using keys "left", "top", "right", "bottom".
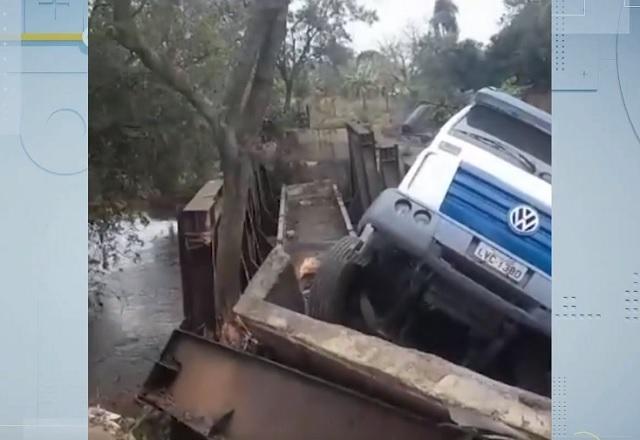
{"left": 440, "top": 167, "right": 551, "bottom": 275}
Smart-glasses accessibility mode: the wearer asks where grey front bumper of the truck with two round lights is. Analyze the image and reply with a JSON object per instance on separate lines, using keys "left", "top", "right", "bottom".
{"left": 359, "top": 189, "right": 551, "bottom": 337}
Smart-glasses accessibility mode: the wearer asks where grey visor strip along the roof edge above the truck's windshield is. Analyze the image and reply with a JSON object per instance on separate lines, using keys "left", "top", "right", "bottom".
{"left": 474, "top": 87, "right": 551, "bottom": 135}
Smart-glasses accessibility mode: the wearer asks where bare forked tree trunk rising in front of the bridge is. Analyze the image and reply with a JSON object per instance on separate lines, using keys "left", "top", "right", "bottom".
{"left": 112, "top": 0, "right": 289, "bottom": 324}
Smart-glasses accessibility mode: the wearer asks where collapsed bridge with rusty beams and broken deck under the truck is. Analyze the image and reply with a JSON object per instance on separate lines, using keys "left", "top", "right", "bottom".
{"left": 139, "top": 124, "right": 551, "bottom": 440}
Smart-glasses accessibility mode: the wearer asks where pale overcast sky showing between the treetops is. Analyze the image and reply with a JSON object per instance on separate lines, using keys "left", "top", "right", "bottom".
{"left": 348, "top": 0, "right": 505, "bottom": 52}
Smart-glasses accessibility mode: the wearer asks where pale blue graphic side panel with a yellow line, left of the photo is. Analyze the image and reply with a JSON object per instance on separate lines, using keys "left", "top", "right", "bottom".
{"left": 0, "top": 0, "right": 88, "bottom": 440}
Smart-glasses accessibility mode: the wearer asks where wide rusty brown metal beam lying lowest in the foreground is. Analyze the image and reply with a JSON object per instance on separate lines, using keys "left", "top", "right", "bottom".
{"left": 139, "top": 331, "right": 450, "bottom": 440}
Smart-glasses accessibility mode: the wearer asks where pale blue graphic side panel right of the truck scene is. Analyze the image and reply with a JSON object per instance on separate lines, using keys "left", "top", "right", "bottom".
{"left": 552, "top": 0, "right": 640, "bottom": 440}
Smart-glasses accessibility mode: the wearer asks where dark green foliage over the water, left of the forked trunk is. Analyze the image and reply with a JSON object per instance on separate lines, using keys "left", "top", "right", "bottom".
{"left": 89, "top": 0, "right": 244, "bottom": 279}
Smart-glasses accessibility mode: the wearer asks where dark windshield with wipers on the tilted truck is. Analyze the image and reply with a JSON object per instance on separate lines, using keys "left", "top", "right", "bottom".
{"left": 452, "top": 105, "right": 551, "bottom": 175}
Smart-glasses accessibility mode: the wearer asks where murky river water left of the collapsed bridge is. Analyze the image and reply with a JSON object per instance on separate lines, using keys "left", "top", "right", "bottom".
{"left": 89, "top": 218, "right": 182, "bottom": 415}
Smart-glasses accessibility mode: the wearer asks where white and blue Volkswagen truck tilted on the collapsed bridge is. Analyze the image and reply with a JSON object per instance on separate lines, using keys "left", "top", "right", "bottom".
{"left": 308, "top": 88, "right": 552, "bottom": 395}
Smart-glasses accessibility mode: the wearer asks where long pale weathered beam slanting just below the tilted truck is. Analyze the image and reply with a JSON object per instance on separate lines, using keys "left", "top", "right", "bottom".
{"left": 234, "top": 276, "right": 551, "bottom": 439}
